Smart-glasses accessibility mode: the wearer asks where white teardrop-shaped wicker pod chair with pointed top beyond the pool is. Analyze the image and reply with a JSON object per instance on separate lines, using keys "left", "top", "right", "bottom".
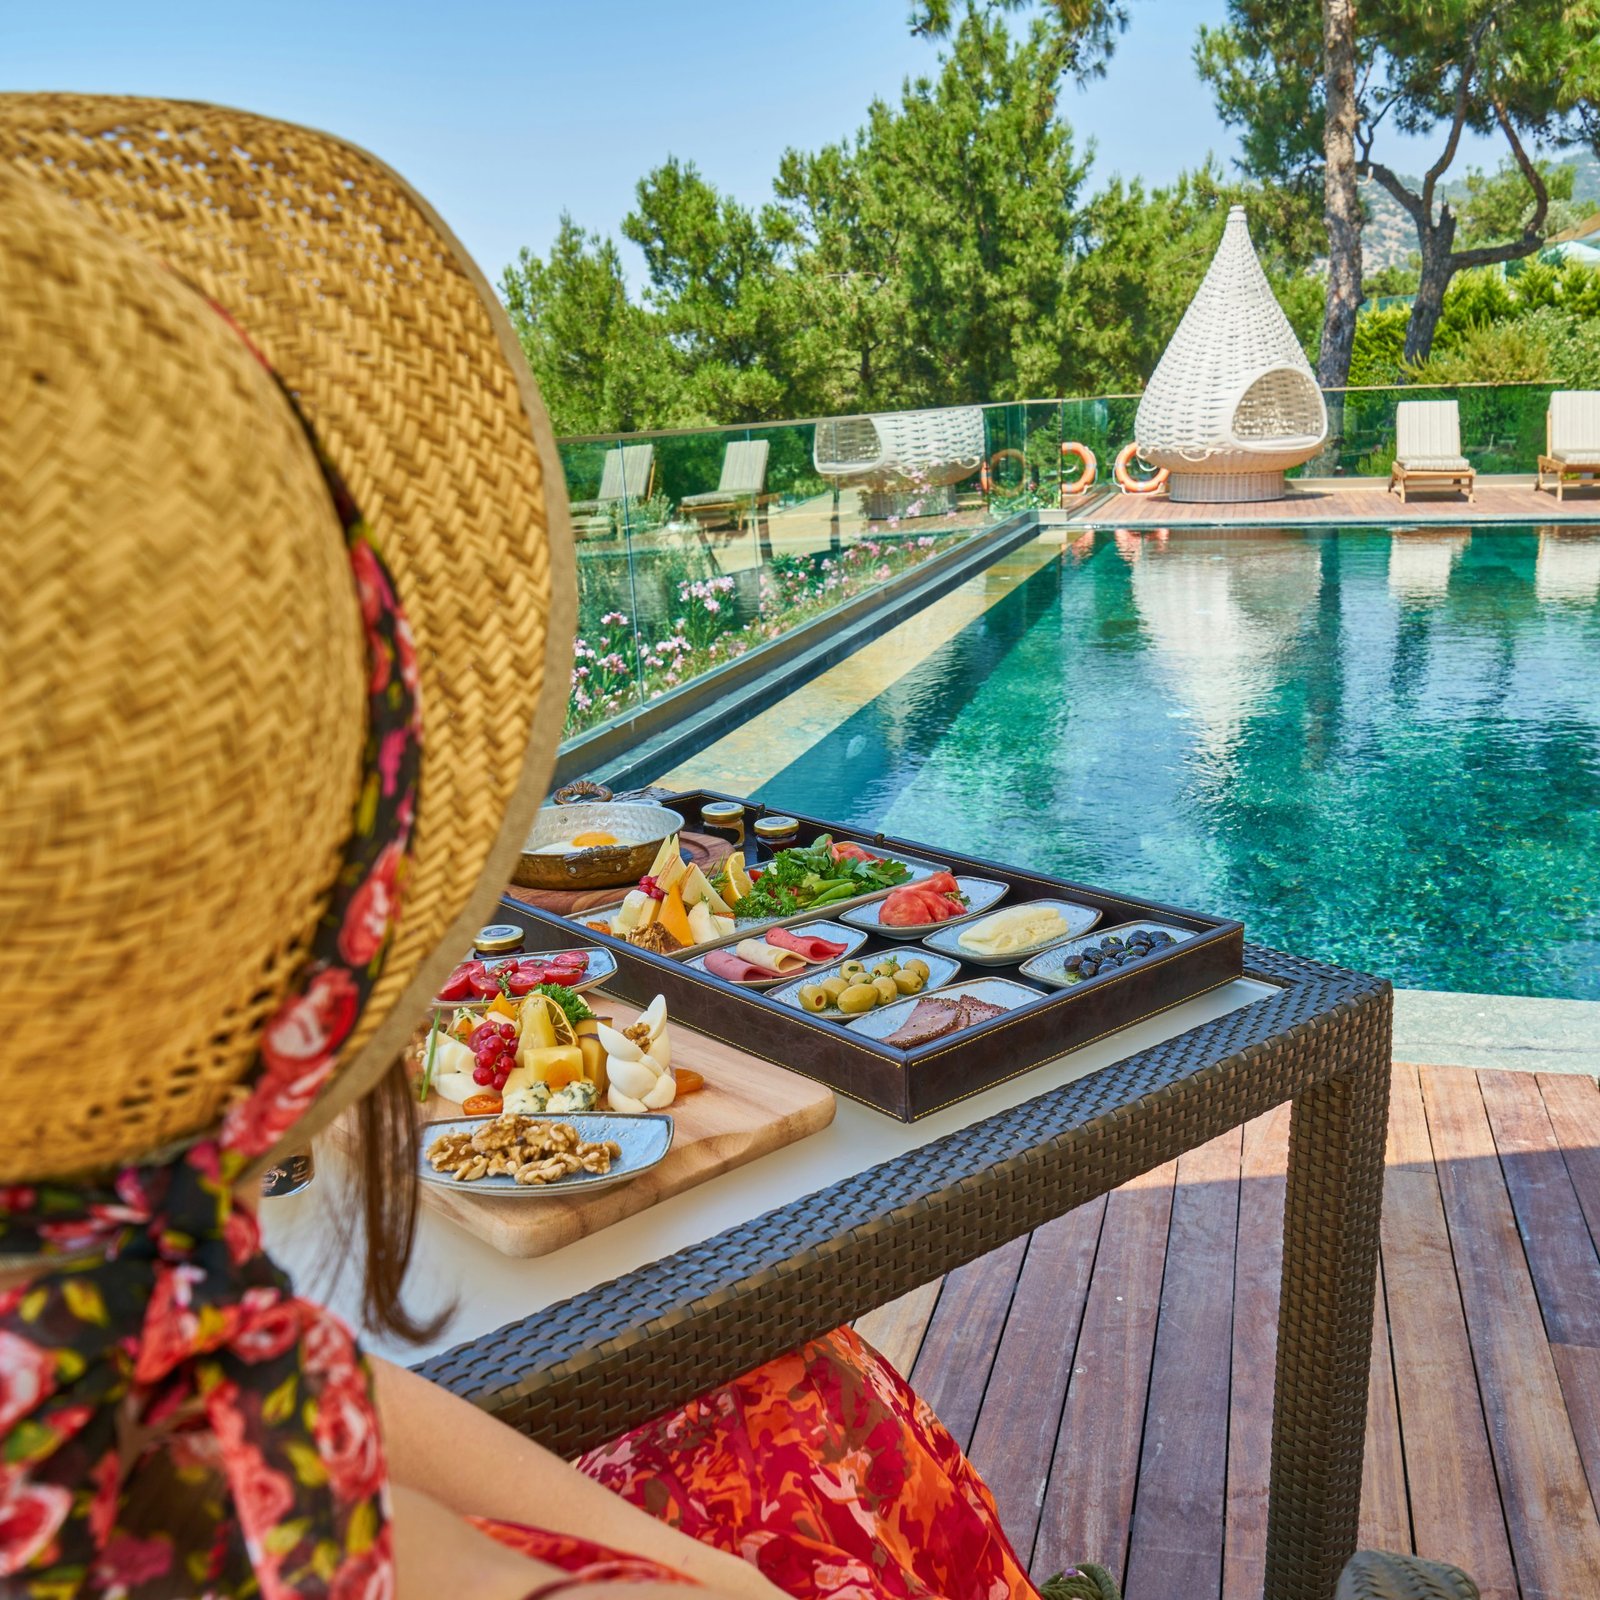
{"left": 1134, "top": 205, "right": 1328, "bottom": 501}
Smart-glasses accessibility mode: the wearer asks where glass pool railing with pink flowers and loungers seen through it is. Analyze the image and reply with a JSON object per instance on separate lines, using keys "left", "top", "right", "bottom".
{"left": 558, "top": 384, "right": 1550, "bottom": 741}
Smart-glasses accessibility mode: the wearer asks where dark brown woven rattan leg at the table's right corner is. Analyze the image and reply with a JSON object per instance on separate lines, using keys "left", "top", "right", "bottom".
{"left": 1266, "top": 992, "right": 1392, "bottom": 1600}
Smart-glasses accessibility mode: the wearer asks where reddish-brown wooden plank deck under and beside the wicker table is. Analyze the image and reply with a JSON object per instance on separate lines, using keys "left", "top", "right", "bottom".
{"left": 861, "top": 1066, "right": 1600, "bottom": 1600}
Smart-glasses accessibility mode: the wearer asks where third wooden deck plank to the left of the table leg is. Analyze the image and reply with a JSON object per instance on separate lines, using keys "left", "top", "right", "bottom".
{"left": 1029, "top": 1162, "right": 1178, "bottom": 1582}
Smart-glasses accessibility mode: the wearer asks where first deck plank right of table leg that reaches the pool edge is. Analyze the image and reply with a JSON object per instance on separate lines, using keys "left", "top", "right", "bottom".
{"left": 1382, "top": 1066, "right": 1517, "bottom": 1600}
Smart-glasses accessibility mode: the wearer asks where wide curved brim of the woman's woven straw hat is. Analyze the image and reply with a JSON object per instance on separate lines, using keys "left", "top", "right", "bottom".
{"left": 0, "top": 94, "right": 576, "bottom": 1181}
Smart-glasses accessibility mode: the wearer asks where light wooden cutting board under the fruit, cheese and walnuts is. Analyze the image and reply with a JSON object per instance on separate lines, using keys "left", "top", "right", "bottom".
{"left": 403, "top": 994, "right": 834, "bottom": 1256}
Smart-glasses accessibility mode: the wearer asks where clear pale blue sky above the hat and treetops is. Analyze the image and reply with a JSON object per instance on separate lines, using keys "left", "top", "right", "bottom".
{"left": 0, "top": 0, "right": 1498, "bottom": 283}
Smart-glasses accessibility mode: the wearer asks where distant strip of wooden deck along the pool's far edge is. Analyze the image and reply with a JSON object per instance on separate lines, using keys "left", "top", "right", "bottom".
{"left": 1074, "top": 478, "right": 1600, "bottom": 528}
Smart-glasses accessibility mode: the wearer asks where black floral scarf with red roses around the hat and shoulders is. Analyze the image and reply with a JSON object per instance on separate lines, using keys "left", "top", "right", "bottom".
{"left": 0, "top": 363, "right": 421, "bottom": 1600}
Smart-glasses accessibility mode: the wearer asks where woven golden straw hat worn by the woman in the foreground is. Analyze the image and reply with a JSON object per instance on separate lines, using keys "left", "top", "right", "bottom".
{"left": 0, "top": 94, "right": 574, "bottom": 1182}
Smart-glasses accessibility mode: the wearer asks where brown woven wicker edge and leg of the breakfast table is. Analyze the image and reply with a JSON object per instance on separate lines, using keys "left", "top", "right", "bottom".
{"left": 400, "top": 946, "right": 1390, "bottom": 1600}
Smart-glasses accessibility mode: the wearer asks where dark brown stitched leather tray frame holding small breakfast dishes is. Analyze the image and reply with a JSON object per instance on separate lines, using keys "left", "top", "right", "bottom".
{"left": 504, "top": 790, "right": 1245, "bottom": 1122}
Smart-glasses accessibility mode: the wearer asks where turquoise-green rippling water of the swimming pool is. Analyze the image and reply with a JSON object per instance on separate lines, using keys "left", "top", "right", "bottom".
{"left": 748, "top": 526, "right": 1600, "bottom": 1000}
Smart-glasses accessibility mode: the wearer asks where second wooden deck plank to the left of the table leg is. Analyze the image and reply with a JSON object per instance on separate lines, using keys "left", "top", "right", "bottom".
{"left": 1126, "top": 1128, "right": 1242, "bottom": 1600}
